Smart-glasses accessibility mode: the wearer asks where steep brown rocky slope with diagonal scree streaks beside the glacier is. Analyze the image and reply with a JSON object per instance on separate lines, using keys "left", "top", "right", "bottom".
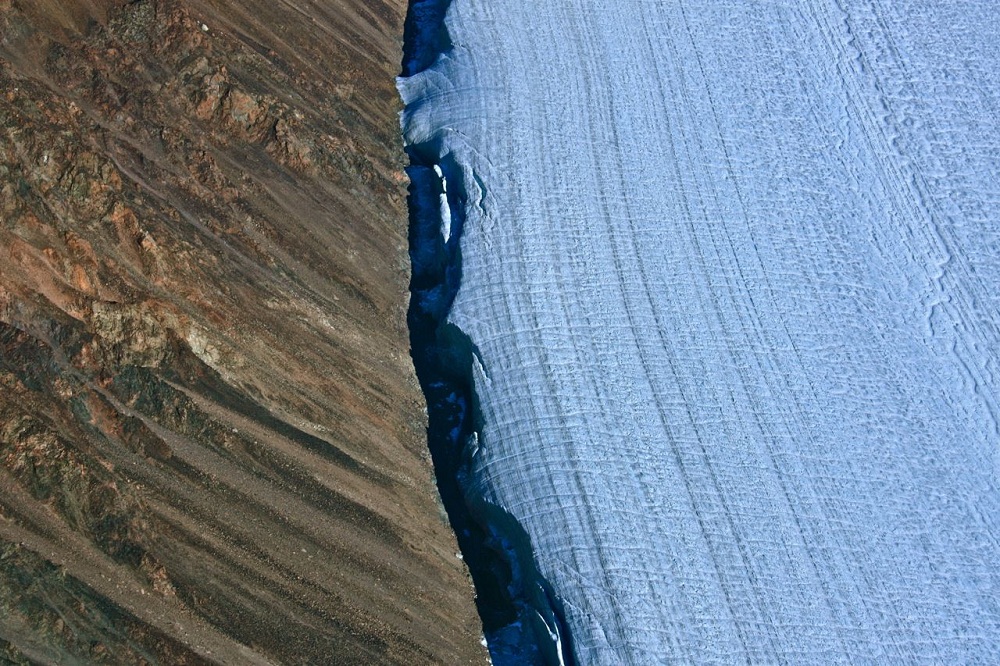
{"left": 0, "top": 0, "right": 485, "bottom": 664}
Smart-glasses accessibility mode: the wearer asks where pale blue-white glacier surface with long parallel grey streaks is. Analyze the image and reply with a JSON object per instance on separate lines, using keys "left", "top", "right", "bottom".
{"left": 400, "top": 0, "right": 1000, "bottom": 664}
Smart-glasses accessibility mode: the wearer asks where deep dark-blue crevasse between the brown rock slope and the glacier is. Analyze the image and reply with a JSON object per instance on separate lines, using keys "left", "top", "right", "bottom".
{"left": 397, "top": 0, "right": 573, "bottom": 666}
